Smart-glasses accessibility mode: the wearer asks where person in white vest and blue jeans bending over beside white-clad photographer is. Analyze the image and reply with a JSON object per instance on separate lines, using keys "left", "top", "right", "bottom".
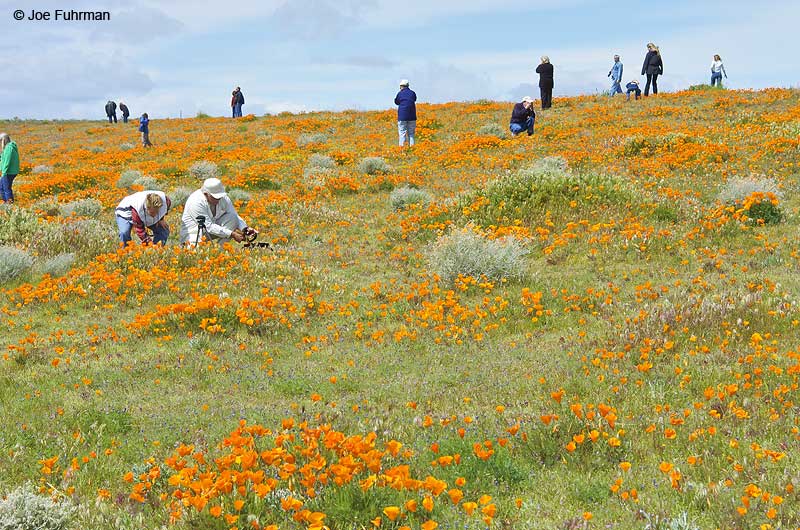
{"left": 116, "top": 191, "right": 171, "bottom": 245}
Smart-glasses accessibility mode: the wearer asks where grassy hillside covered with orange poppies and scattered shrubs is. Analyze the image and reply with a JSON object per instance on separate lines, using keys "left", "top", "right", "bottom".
{"left": 0, "top": 89, "right": 800, "bottom": 530}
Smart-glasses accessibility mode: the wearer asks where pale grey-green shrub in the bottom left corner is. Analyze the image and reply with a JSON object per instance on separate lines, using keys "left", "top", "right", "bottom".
{"left": 0, "top": 485, "right": 75, "bottom": 530}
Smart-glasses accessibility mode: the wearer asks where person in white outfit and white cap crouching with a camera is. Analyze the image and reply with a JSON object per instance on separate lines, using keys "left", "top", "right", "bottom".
{"left": 180, "top": 178, "right": 255, "bottom": 245}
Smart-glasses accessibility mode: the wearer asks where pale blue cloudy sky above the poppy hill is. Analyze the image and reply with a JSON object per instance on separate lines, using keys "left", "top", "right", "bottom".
{"left": 0, "top": 0, "right": 800, "bottom": 119}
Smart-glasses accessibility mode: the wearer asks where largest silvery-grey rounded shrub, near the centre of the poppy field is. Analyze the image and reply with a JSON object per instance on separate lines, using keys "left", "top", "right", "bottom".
{"left": 428, "top": 224, "right": 527, "bottom": 281}
